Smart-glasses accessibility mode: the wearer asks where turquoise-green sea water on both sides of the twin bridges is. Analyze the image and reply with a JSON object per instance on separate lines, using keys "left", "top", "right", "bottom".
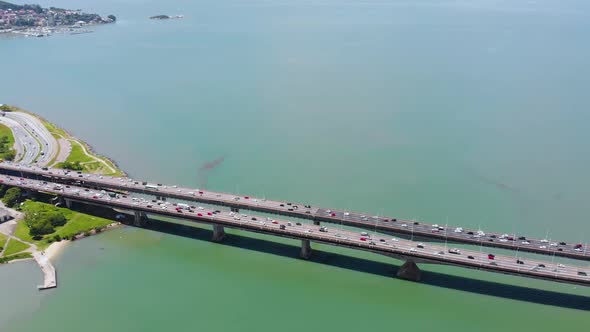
{"left": 0, "top": 0, "right": 590, "bottom": 331}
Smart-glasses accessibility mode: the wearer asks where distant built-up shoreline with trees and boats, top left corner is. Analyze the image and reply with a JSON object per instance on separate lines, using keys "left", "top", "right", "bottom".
{"left": 0, "top": 1, "right": 117, "bottom": 37}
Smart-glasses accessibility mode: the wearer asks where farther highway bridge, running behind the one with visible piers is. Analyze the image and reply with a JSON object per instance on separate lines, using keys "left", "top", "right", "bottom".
{"left": 0, "top": 162, "right": 590, "bottom": 261}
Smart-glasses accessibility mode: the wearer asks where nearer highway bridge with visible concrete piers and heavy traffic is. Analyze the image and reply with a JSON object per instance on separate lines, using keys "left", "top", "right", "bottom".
{"left": 0, "top": 174, "right": 590, "bottom": 286}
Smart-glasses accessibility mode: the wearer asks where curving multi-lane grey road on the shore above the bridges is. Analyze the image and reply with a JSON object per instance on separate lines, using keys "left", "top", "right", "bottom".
{"left": 3, "top": 112, "right": 59, "bottom": 166}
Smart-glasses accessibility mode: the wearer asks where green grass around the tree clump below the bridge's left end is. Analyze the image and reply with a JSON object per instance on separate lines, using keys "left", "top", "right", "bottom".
{"left": 14, "top": 201, "right": 113, "bottom": 250}
